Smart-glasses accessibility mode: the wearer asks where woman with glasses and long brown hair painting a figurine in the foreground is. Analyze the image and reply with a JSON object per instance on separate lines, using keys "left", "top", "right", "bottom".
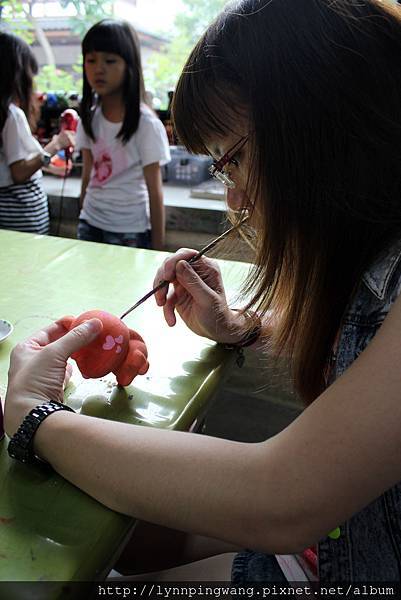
{"left": 6, "top": 0, "right": 401, "bottom": 582}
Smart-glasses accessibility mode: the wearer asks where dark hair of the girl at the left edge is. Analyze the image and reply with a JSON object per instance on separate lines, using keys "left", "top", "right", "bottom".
{"left": 0, "top": 31, "right": 38, "bottom": 133}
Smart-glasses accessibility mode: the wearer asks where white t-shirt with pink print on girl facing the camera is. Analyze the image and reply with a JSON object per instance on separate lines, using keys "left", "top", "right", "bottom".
{"left": 76, "top": 105, "right": 170, "bottom": 233}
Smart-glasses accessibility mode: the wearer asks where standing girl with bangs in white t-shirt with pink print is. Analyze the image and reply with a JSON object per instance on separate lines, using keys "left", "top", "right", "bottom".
{"left": 77, "top": 19, "right": 170, "bottom": 250}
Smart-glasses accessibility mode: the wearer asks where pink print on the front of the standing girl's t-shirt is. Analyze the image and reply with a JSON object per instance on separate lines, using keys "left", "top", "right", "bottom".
{"left": 91, "top": 138, "right": 128, "bottom": 187}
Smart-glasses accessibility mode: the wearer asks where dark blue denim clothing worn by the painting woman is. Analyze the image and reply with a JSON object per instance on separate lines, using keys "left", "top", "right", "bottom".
{"left": 232, "top": 239, "right": 401, "bottom": 583}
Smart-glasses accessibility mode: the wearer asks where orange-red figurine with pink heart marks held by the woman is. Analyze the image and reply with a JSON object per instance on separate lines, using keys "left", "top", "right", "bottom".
{"left": 61, "top": 310, "right": 149, "bottom": 386}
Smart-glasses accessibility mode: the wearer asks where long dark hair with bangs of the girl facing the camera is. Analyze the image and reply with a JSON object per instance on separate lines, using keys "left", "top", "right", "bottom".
{"left": 81, "top": 19, "right": 145, "bottom": 143}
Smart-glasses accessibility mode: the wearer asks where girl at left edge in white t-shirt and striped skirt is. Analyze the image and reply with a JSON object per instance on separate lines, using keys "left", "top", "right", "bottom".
{"left": 0, "top": 31, "right": 74, "bottom": 234}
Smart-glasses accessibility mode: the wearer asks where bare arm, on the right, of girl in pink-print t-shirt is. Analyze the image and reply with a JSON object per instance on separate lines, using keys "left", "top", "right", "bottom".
{"left": 143, "top": 162, "right": 166, "bottom": 250}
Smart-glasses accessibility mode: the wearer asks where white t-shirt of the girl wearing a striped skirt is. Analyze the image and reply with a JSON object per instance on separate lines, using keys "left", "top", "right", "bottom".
{"left": 0, "top": 104, "right": 42, "bottom": 187}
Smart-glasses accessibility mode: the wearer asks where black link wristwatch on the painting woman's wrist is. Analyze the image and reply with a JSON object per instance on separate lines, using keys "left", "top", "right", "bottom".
{"left": 7, "top": 400, "right": 75, "bottom": 464}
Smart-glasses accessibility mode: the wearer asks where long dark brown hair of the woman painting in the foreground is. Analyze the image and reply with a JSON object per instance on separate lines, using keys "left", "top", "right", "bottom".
{"left": 173, "top": 0, "right": 401, "bottom": 402}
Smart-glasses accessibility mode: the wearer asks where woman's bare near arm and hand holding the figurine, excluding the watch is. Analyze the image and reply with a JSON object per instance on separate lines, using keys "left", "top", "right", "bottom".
{"left": 5, "top": 297, "right": 401, "bottom": 553}
